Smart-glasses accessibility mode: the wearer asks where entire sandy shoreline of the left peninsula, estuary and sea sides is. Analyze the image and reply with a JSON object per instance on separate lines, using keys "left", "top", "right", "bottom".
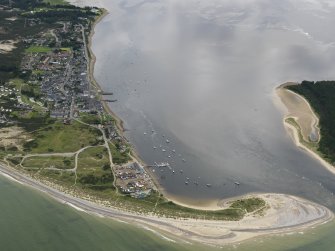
{"left": 0, "top": 0, "right": 334, "bottom": 245}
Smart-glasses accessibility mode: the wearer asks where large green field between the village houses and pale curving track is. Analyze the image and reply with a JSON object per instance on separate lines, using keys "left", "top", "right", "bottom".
{"left": 24, "top": 121, "right": 101, "bottom": 153}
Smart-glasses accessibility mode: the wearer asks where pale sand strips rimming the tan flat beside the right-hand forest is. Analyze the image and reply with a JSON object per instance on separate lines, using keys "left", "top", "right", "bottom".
{"left": 275, "top": 82, "right": 335, "bottom": 174}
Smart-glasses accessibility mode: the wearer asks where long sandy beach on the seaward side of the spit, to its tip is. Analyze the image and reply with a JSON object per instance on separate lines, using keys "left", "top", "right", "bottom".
{"left": 0, "top": 164, "right": 334, "bottom": 246}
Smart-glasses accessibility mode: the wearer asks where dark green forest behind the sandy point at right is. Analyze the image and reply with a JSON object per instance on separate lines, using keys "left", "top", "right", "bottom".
{"left": 287, "top": 81, "right": 335, "bottom": 163}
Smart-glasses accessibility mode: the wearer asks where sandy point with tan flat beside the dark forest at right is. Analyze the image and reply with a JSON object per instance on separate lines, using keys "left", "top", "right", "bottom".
{"left": 275, "top": 82, "right": 335, "bottom": 174}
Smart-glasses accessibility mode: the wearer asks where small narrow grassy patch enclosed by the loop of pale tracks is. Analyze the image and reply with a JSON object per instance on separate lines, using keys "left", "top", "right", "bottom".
{"left": 22, "top": 156, "right": 74, "bottom": 169}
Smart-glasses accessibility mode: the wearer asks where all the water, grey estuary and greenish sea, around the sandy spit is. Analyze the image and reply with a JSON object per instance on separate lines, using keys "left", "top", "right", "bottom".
{"left": 0, "top": 0, "right": 335, "bottom": 251}
